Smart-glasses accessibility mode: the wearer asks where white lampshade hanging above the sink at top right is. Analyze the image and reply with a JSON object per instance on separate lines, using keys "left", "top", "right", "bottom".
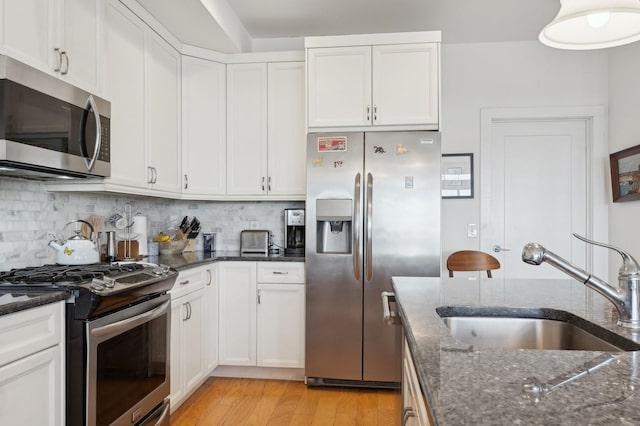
{"left": 538, "top": 0, "right": 640, "bottom": 50}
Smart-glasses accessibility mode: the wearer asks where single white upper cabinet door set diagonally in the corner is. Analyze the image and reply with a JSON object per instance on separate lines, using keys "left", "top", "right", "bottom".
{"left": 182, "top": 56, "right": 227, "bottom": 195}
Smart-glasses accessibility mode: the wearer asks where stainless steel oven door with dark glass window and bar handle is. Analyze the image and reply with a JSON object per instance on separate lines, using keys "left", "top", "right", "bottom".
{"left": 86, "top": 294, "right": 171, "bottom": 426}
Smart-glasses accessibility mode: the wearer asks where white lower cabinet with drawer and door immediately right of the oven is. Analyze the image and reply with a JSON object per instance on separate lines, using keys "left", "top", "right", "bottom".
{"left": 171, "top": 268, "right": 205, "bottom": 412}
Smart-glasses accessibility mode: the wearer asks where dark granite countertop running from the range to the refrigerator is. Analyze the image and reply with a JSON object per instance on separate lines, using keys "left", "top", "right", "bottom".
{"left": 145, "top": 251, "right": 304, "bottom": 270}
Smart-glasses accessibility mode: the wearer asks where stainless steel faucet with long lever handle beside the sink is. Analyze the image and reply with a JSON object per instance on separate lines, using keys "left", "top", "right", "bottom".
{"left": 522, "top": 233, "right": 640, "bottom": 329}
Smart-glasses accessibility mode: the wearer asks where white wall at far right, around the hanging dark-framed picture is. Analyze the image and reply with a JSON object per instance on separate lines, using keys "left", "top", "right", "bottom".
{"left": 609, "top": 42, "right": 640, "bottom": 277}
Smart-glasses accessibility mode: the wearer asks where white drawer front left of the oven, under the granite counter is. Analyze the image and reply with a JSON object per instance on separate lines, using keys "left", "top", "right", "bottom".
{"left": 0, "top": 302, "right": 64, "bottom": 365}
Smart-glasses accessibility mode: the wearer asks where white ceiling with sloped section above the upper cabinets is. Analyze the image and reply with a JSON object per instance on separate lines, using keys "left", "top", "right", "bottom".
{"left": 137, "top": 0, "right": 560, "bottom": 52}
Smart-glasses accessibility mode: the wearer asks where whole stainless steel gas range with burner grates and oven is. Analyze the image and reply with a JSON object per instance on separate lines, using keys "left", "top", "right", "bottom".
{"left": 0, "top": 263, "right": 178, "bottom": 426}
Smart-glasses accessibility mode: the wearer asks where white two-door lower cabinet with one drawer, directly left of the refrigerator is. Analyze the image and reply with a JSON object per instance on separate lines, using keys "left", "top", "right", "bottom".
{"left": 219, "top": 261, "right": 305, "bottom": 368}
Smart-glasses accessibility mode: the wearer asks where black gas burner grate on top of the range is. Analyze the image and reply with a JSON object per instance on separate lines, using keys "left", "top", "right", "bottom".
{"left": 0, "top": 263, "right": 144, "bottom": 285}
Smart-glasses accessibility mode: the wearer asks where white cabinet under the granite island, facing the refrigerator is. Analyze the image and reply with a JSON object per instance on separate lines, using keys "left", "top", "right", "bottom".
{"left": 402, "top": 340, "right": 431, "bottom": 426}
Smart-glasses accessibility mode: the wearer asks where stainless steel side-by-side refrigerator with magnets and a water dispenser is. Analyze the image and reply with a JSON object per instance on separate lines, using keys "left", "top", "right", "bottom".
{"left": 305, "top": 132, "right": 440, "bottom": 386}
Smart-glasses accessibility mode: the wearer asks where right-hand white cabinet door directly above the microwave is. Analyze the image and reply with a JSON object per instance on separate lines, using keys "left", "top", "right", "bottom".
{"left": 60, "top": 0, "right": 103, "bottom": 93}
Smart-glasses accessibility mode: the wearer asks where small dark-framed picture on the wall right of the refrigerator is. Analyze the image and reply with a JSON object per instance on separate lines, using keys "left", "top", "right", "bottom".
{"left": 440, "top": 153, "right": 473, "bottom": 198}
